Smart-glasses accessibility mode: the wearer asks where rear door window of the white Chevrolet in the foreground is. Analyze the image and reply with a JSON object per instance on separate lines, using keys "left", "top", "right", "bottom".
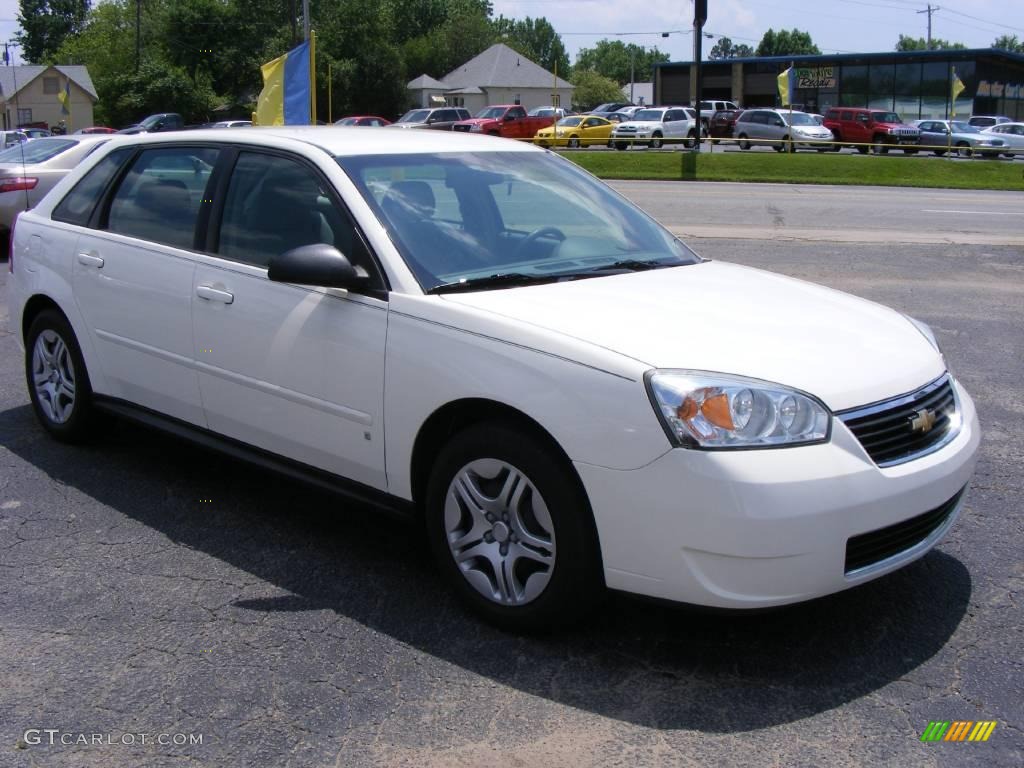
{"left": 106, "top": 146, "right": 218, "bottom": 249}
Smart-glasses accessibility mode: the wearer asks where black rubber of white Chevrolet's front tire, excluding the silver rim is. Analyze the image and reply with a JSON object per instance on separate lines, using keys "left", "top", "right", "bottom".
{"left": 425, "top": 422, "right": 603, "bottom": 632}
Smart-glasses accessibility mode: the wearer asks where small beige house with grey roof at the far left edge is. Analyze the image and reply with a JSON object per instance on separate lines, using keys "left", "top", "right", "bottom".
{"left": 0, "top": 65, "right": 99, "bottom": 133}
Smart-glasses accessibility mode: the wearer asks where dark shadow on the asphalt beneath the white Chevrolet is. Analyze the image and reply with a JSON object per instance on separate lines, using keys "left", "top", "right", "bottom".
{"left": 0, "top": 406, "right": 972, "bottom": 733}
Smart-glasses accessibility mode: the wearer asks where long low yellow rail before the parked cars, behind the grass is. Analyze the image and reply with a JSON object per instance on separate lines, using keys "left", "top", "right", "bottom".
{"left": 517, "top": 134, "right": 1024, "bottom": 158}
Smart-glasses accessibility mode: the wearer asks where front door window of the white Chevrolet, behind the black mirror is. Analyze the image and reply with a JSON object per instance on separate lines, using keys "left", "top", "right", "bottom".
{"left": 217, "top": 152, "right": 381, "bottom": 287}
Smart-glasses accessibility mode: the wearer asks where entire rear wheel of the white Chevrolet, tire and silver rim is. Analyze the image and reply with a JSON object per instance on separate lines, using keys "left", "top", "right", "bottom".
{"left": 25, "top": 309, "right": 93, "bottom": 442}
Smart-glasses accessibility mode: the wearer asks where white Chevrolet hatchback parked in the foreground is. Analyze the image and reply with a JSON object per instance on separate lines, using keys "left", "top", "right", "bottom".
{"left": 8, "top": 127, "right": 980, "bottom": 629}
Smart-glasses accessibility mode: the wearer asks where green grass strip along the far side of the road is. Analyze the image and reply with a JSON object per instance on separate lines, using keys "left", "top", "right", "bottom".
{"left": 562, "top": 150, "right": 1024, "bottom": 190}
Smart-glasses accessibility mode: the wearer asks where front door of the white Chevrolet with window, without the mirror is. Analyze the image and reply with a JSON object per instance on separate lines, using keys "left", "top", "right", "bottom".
{"left": 191, "top": 152, "right": 388, "bottom": 489}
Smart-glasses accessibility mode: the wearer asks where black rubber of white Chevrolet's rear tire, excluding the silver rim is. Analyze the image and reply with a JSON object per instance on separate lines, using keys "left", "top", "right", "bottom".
{"left": 25, "top": 309, "right": 94, "bottom": 442}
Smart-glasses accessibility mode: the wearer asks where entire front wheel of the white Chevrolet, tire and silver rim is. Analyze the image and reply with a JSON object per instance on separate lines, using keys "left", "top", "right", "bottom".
{"left": 426, "top": 423, "right": 602, "bottom": 631}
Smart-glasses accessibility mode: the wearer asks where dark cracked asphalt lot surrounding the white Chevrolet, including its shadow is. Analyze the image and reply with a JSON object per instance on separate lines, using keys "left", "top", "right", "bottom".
{"left": 0, "top": 188, "right": 1024, "bottom": 768}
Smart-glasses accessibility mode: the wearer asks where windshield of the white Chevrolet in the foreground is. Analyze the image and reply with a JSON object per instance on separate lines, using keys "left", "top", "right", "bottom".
{"left": 338, "top": 152, "right": 699, "bottom": 291}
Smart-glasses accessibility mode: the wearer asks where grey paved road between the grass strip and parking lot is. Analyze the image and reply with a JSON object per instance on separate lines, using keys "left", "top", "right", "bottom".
{"left": 611, "top": 181, "right": 1024, "bottom": 247}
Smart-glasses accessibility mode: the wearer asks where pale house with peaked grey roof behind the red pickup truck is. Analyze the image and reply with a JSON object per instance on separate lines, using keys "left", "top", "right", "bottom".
{"left": 406, "top": 43, "right": 573, "bottom": 114}
